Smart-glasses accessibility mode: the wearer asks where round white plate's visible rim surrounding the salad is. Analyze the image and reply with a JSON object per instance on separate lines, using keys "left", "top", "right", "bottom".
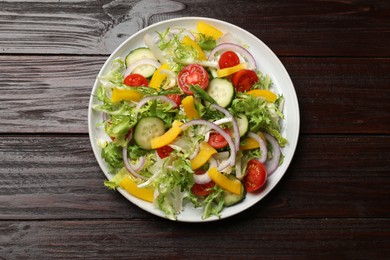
{"left": 88, "top": 17, "right": 300, "bottom": 222}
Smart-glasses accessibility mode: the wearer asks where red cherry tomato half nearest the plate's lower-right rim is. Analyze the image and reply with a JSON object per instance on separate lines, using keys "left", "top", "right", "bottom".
{"left": 244, "top": 159, "right": 267, "bottom": 192}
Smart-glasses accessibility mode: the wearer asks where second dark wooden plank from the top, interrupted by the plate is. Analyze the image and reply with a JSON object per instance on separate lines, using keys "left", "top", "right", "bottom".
{"left": 0, "top": 55, "right": 390, "bottom": 134}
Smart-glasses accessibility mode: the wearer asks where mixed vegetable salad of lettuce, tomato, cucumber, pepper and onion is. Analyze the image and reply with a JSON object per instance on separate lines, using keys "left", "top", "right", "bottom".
{"left": 93, "top": 21, "right": 288, "bottom": 219}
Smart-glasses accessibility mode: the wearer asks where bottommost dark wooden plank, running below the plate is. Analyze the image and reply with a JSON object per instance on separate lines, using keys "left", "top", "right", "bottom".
{"left": 0, "top": 218, "right": 390, "bottom": 259}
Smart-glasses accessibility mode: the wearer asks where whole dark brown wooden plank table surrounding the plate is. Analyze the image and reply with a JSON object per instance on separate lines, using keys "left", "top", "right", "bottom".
{"left": 0, "top": 0, "right": 390, "bottom": 259}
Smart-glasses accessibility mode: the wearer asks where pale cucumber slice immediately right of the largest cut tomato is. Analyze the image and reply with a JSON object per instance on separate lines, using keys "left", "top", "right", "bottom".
{"left": 206, "top": 78, "right": 235, "bottom": 107}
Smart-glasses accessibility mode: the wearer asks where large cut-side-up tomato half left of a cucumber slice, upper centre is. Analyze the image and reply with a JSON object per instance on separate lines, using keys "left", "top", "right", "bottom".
{"left": 177, "top": 64, "right": 209, "bottom": 95}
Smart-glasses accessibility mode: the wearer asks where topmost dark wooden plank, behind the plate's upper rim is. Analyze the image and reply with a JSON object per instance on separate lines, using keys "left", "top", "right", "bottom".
{"left": 0, "top": 0, "right": 390, "bottom": 57}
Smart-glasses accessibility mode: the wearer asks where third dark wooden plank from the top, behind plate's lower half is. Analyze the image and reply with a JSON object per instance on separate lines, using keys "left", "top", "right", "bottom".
{"left": 0, "top": 135, "right": 390, "bottom": 220}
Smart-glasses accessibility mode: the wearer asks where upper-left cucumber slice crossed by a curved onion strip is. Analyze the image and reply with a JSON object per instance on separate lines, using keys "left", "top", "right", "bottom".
{"left": 126, "top": 47, "right": 157, "bottom": 78}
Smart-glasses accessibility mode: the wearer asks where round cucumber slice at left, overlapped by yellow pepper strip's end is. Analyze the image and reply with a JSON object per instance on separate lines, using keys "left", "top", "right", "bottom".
{"left": 133, "top": 117, "right": 165, "bottom": 150}
